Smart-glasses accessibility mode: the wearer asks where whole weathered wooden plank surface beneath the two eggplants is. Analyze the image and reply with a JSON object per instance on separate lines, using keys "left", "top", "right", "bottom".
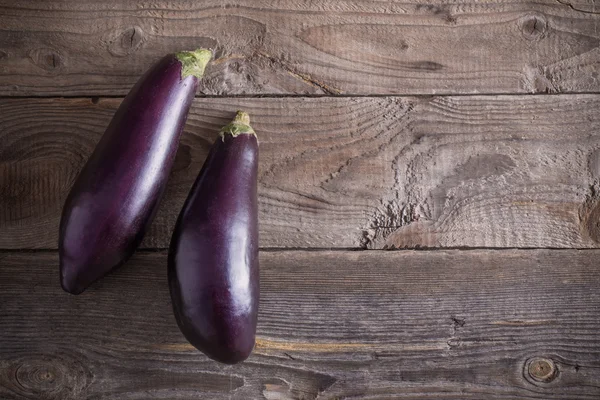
{"left": 0, "top": 0, "right": 600, "bottom": 400}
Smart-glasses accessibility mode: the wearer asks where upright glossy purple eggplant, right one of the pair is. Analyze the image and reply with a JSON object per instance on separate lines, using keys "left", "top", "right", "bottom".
{"left": 168, "top": 111, "right": 259, "bottom": 364}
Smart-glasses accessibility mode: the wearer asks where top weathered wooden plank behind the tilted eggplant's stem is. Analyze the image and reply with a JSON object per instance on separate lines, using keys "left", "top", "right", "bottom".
{"left": 0, "top": 0, "right": 600, "bottom": 95}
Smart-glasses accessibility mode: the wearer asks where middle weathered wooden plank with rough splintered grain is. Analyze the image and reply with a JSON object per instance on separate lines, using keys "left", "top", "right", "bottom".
{"left": 0, "top": 95, "right": 600, "bottom": 249}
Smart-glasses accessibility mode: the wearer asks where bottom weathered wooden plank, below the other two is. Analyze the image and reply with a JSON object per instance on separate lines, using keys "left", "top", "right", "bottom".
{"left": 0, "top": 250, "right": 600, "bottom": 400}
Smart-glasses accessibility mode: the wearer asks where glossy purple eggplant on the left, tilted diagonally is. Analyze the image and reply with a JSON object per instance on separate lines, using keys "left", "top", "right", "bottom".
{"left": 59, "top": 49, "right": 212, "bottom": 294}
